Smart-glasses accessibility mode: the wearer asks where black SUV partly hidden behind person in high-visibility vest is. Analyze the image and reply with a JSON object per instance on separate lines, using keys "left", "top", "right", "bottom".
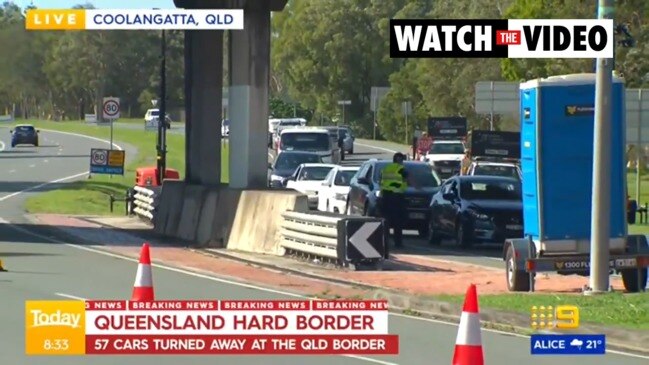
{"left": 347, "top": 159, "right": 441, "bottom": 237}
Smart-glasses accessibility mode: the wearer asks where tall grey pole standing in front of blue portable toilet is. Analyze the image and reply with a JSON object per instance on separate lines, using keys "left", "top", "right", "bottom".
{"left": 586, "top": 0, "right": 615, "bottom": 294}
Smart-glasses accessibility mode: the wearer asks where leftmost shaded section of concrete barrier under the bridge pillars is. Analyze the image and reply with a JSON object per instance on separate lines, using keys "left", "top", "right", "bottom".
{"left": 153, "top": 179, "right": 185, "bottom": 237}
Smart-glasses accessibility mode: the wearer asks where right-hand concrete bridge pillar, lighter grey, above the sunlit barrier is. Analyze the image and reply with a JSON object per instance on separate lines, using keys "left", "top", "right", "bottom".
{"left": 228, "top": 1, "right": 271, "bottom": 189}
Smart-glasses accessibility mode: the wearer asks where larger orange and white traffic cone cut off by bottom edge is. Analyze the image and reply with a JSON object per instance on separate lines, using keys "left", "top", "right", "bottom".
{"left": 452, "top": 284, "right": 484, "bottom": 365}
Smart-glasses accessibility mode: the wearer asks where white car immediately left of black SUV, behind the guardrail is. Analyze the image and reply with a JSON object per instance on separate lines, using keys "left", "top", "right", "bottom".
{"left": 317, "top": 166, "right": 359, "bottom": 214}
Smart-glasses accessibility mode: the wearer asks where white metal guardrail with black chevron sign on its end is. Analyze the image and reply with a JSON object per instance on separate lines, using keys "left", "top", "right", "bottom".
{"left": 280, "top": 211, "right": 386, "bottom": 267}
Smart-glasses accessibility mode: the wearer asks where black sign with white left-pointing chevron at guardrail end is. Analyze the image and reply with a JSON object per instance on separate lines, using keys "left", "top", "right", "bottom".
{"left": 342, "top": 218, "right": 385, "bottom": 262}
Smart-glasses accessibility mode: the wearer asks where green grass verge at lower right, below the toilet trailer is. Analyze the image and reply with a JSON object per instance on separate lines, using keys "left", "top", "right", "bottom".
{"left": 435, "top": 293, "right": 649, "bottom": 330}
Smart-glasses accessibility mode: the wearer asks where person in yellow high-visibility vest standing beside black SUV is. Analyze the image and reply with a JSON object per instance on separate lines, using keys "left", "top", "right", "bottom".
{"left": 379, "top": 152, "right": 408, "bottom": 253}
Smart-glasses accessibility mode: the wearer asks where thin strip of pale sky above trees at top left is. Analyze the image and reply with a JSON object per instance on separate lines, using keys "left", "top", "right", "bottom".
{"left": 10, "top": 0, "right": 175, "bottom": 9}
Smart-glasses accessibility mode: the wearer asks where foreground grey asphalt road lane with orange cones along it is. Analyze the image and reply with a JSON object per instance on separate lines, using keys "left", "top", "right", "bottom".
{"left": 0, "top": 225, "right": 648, "bottom": 365}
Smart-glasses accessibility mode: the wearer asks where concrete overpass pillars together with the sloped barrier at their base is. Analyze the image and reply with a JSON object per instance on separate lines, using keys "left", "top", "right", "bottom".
{"left": 153, "top": 0, "right": 300, "bottom": 250}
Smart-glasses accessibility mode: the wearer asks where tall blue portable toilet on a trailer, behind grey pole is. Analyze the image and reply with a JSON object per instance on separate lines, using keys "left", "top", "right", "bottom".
{"left": 520, "top": 74, "right": 626, "bottom": 246}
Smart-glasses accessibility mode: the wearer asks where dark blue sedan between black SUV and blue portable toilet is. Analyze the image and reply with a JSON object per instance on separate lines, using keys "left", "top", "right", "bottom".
{"left": 429, "top": 175, "right": 523, "bottom": 247}
